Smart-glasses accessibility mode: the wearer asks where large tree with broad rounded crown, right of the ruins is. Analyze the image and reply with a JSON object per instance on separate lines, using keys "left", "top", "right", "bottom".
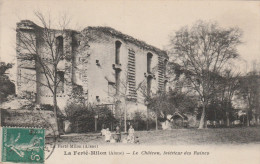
{"left": 170, "top": 21, "right": 242, "bottom": 129}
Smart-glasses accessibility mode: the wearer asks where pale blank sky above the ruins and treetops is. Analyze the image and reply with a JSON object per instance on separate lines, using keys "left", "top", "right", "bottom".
{"left": 0, "top": 0, "right": 260, "bottom": 72}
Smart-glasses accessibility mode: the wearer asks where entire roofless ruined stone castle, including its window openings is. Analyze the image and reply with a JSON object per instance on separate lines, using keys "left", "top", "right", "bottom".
{"left": 17, "top": 20, "right": 168, "bottom": 118}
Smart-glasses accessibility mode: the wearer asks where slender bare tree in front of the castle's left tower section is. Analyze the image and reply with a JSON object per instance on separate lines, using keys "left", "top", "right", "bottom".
{"left": 16, "top": 12, "right": 74, "bottom": 135}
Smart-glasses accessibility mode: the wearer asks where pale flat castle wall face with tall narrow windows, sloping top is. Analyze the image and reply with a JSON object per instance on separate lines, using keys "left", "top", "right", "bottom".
{"left": 85, "top": 31, "right": 167, "bottom": 113}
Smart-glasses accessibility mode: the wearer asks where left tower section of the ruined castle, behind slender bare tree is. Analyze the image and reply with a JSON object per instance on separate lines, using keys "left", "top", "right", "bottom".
{"left": 17, "top": 21, "right": 76, "bottom": 109}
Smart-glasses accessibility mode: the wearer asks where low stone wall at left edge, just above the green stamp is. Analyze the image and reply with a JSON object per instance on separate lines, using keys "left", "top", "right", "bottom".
{"left": 0, "top": 109, "right": 57, "bottom": 137}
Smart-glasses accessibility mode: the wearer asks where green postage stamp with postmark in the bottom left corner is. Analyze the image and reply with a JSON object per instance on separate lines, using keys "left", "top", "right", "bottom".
{"left": 1, "top": 127, "right": 45, "bottom": 163}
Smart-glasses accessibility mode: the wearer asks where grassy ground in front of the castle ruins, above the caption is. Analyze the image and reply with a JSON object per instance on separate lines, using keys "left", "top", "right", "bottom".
{"left": 53, "top": 127, "right": 260, "bottom": 145}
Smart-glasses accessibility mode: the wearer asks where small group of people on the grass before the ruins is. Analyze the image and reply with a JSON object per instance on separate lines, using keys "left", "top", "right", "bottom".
{"left": 101, "top": 125, "right": 138, "bottom": 143}
